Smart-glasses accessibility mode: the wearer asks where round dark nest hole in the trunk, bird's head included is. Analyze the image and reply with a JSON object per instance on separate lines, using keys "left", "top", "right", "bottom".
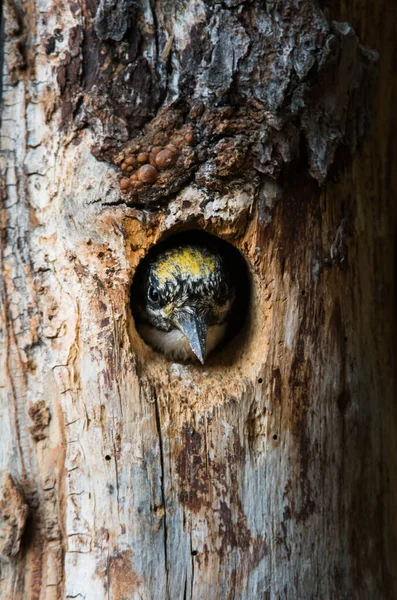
{"left": 131, "top": 230, "right": 251, "bottom": 366}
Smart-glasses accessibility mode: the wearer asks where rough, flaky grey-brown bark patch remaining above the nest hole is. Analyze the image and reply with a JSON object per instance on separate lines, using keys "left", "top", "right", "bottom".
{"left": 76, "top": 0, "right": 376, "bottom": 205}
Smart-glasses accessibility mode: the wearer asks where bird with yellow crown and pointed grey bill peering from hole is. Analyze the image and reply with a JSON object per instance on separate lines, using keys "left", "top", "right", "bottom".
{"left": 136, "top": 243, "right": 235, "bottom": 364}
